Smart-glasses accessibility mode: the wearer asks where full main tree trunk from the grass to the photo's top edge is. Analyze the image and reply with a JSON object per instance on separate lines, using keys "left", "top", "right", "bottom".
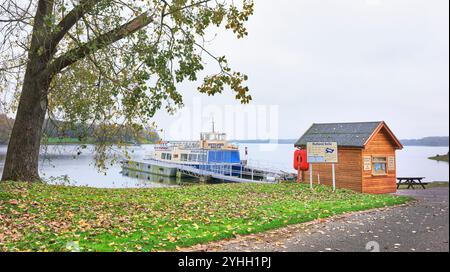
{"left": 2, "top": 0, "right": 54, "bottom": 182}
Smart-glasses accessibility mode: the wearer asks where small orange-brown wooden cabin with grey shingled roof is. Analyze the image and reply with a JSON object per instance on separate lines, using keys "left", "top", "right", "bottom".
{"left": 295, "top": 122, "right": 403, "bottom": 194}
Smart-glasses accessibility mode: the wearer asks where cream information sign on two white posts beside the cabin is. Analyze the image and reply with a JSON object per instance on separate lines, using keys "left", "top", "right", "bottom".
{"left": 306, "top": 142, "right": 338, "bottom": 192}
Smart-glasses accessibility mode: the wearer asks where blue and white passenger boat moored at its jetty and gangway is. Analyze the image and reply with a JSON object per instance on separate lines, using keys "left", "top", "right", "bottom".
{"left": 122, "top": 126, "right": 296, "bottom": 182}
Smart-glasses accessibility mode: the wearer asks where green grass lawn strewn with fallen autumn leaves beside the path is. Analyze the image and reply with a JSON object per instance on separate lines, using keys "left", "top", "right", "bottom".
{"left": 0, "top": 182, "right": 410, "bottom": 251}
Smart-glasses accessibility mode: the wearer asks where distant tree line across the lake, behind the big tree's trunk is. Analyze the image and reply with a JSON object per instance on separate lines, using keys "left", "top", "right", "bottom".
{"left": 0, "top": 114, "right": 160, "bottom": 144}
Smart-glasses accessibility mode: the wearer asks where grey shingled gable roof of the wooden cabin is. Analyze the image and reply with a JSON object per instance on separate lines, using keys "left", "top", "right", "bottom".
{"left": 295, "top": 121, "right": 402, "bottom": 148}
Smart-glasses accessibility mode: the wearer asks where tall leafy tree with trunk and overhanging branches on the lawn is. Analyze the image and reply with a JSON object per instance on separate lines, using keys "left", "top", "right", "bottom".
{"left": 0, "top": 0, "right": 253, "bottom": 181}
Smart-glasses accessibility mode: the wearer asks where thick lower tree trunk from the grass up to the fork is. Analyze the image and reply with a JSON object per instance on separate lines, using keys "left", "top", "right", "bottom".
{"left": 2, "top": 69, "right": 50, "bottom": 182}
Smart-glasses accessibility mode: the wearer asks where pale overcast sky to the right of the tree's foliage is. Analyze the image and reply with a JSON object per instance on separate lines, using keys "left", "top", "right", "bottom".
{"left": 155, "top": 0, "right": 449, "bottom": 139}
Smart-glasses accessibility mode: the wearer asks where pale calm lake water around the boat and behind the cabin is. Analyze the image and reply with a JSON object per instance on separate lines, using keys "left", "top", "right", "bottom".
{"left": 0, "top": 144, "right": 449, "bottom": 188}
